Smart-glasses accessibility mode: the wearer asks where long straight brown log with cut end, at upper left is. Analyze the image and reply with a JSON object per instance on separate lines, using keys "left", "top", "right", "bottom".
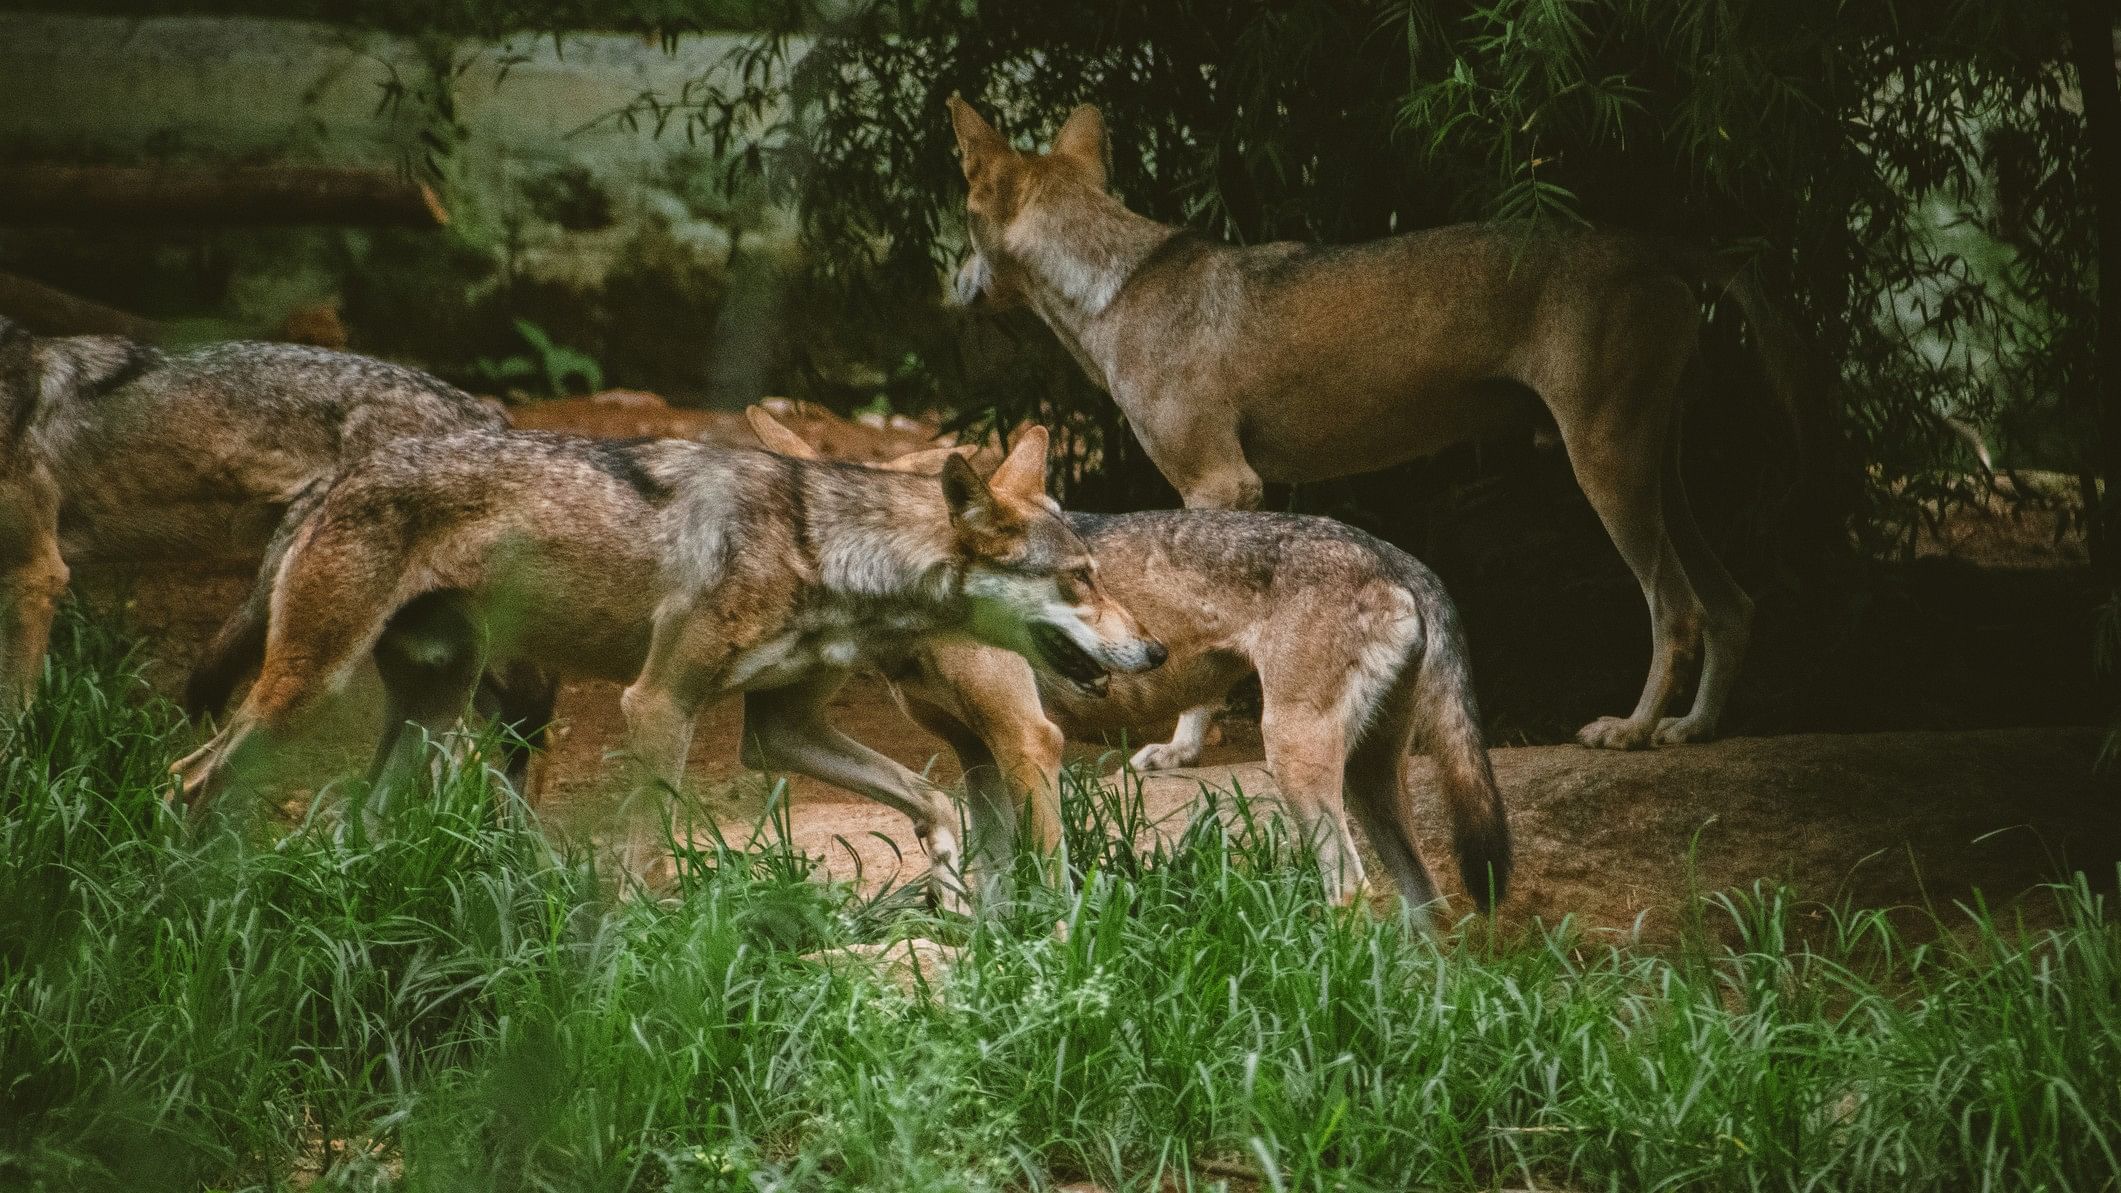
{"left": 0, "top": 161, "right": 450, "bottom": 227}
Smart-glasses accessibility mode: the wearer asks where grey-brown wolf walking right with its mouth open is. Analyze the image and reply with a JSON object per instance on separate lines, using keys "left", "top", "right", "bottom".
{"left": 176, "top": 429, "right": 1164, "bottom": 898}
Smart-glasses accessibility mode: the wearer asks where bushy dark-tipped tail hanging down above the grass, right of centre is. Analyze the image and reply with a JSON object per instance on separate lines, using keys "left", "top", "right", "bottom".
{"left": 1415, "top": 597, "right": 1510, "bottom": 911}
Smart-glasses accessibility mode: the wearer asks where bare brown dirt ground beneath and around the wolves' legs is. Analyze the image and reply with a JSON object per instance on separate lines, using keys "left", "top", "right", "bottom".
{"left": 103, "top": 390, "right": 2121, "bottom": 940}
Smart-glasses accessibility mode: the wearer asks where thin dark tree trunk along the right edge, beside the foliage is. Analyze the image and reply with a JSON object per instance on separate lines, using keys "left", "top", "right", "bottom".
{"left": 2070, "top": 0, "right": 2121, "bottom": 586}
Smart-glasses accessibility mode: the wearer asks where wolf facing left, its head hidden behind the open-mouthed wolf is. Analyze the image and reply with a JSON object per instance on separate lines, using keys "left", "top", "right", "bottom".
{"left": 749, "top": 408, "right": 1510, "bottom": 913}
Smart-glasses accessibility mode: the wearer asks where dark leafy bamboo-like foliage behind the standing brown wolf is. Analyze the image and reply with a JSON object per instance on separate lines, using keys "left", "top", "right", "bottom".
{"left": 615, "top": 0, "right": 2096, "bottom": 541}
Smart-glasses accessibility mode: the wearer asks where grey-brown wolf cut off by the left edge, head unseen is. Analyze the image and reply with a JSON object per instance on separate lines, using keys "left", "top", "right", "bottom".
{"left": 0, "top": 318, "right": 507, "bottom": 709}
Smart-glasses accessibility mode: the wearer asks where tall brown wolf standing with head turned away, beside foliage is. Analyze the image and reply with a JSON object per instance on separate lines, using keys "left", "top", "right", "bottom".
{"left": 950, "top": 98, "right": 1790, "bottom": 747}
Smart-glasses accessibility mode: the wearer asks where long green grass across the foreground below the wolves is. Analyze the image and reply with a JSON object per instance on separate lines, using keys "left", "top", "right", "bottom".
{"left": 0, "top": 622, "right": 2121, "bottom": 1193}
